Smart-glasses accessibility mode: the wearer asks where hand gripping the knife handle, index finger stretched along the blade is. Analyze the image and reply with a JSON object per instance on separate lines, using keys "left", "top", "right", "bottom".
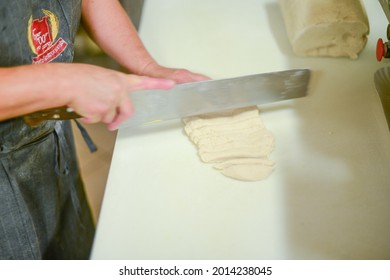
{"left": 65, "top": 64, "right": 175, "bottom": 130}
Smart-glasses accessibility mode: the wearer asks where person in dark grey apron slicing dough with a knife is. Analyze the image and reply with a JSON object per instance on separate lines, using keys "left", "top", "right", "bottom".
{"left": 0, "top": 0, "right": 207, "bottom": 259}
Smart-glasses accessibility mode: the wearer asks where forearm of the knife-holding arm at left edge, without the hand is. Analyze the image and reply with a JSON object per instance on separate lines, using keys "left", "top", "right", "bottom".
{"left": 0, "top": 64, "right": 67, "bottom": 120}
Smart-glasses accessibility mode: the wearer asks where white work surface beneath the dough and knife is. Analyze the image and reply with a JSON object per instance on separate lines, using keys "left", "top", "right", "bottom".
{"left": 92, "top": 0, "right": 390, "bottom": 259}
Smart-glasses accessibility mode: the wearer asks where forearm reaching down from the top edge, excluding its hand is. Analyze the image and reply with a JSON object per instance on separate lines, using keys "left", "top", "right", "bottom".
{"left": 82, "top": 0, "right": 155, "bottom": 75}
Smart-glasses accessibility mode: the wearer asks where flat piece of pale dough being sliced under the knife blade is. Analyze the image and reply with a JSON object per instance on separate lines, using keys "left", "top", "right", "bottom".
{"left": 183, "top": 106, "right": 275, "bottom": 181}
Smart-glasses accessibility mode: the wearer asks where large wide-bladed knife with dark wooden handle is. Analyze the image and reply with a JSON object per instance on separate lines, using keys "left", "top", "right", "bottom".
{"left": 24, "top": 69, "right": 310, "bottom": 127}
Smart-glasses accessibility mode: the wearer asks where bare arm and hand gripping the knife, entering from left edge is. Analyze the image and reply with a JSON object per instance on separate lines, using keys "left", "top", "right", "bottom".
{"left": 0, "top": 63, "right": 174, "bottom": 130}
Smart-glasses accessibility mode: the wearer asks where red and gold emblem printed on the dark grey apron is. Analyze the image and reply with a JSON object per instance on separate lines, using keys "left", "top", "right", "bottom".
{"left": 27, "top": 10, "right": 68, "bottom": 64}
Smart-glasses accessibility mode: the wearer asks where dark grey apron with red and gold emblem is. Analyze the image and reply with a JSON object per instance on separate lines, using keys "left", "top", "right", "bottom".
{"left": 0, "top": 0, "right": 94, "bottom": 259}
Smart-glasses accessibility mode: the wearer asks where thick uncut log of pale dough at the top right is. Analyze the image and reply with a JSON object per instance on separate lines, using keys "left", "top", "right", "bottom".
{"left": 279, "top": 0, "right": 369, "bottom": 59}
